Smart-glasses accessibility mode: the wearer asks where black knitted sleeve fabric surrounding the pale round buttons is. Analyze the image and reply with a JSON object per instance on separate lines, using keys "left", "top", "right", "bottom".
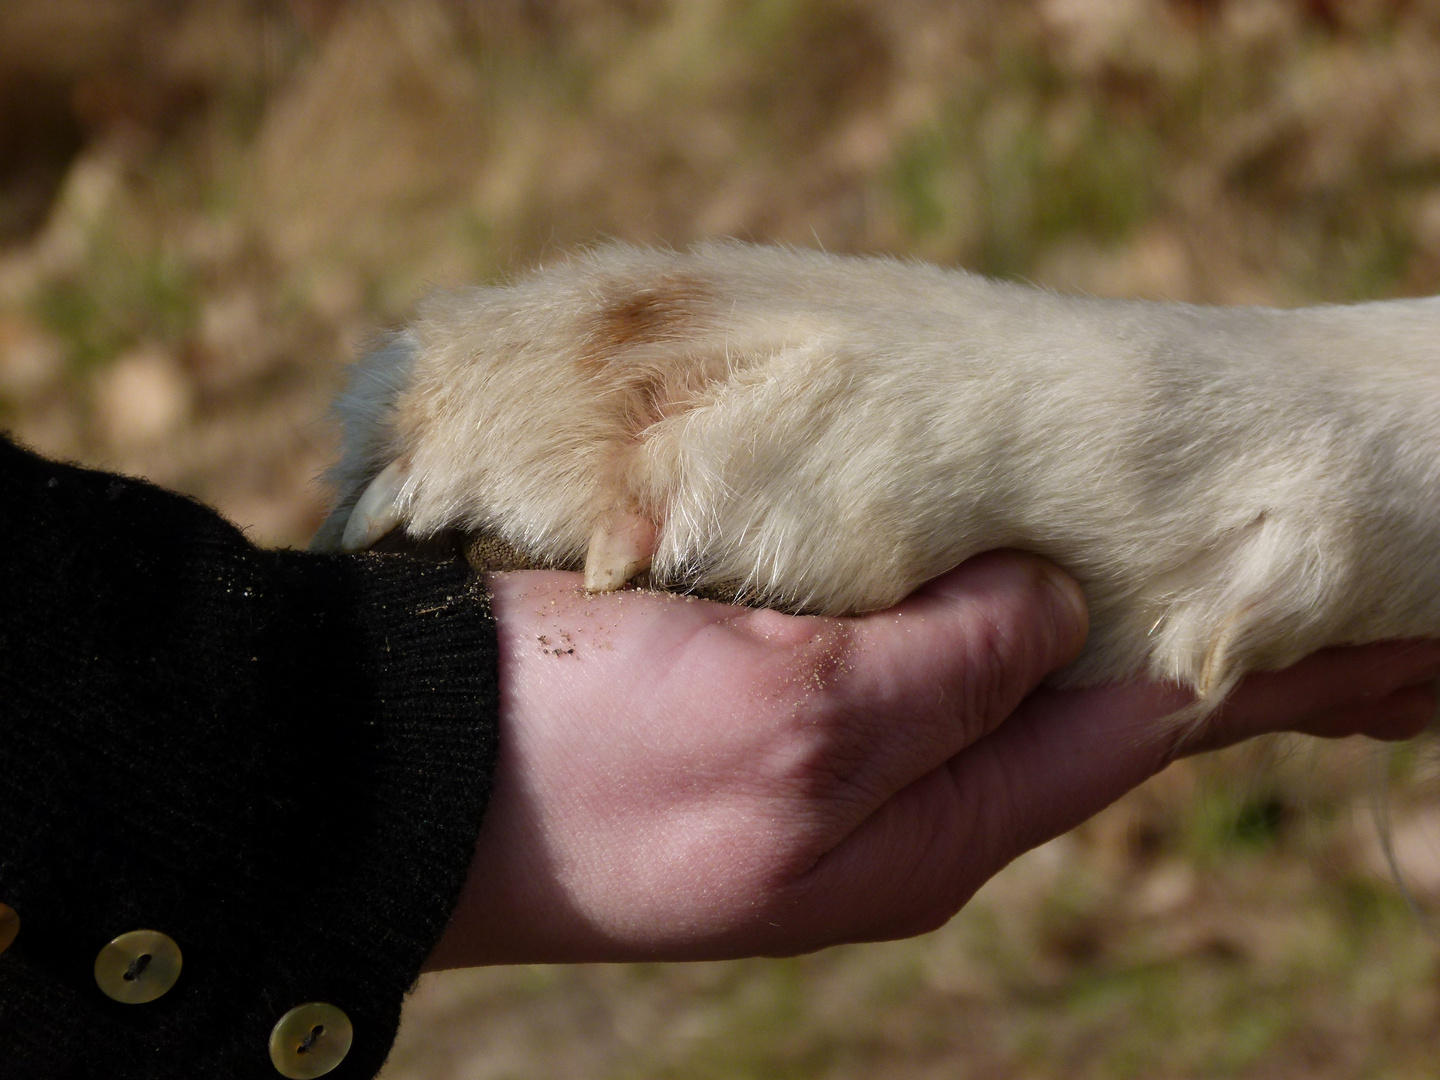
{"left": 0, "top": 439, "right": 497, "bottom": 1080}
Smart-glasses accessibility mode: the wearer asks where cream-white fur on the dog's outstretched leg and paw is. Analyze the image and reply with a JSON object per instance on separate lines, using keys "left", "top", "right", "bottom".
{"left": 315, "top": 243, "right": 1440, "bottom": 703}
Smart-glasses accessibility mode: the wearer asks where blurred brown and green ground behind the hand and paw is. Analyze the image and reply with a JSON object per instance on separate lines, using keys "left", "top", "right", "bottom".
{"left": 8, "top": 0, "right": 1440, "bottom": 1080}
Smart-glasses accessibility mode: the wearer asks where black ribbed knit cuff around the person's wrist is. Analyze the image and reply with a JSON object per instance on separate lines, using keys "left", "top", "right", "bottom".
{"left": 236, "top": 553, "right": 498, "bottom": 1080}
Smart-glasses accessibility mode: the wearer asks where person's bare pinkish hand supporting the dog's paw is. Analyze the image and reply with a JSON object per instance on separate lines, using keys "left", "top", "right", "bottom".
{"left": 426, "top": 552, "right": 1440, "bottom": 971}
